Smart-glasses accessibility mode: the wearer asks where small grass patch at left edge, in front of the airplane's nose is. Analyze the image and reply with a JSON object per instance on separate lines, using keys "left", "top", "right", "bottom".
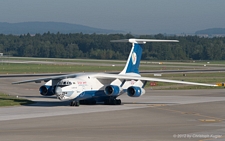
{"left": 0, "top": 94, "right": 34, "bottom": 107}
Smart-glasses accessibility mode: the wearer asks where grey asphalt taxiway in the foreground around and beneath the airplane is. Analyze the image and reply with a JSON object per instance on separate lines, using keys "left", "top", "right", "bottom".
{"left": 0, "top": 77, "right": 225, "bottom": 141}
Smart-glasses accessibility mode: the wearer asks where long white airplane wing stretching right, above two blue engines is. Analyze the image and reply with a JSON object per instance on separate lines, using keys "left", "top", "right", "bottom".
{"left": 95, "top": 74, "right": 218, "bottom": 87}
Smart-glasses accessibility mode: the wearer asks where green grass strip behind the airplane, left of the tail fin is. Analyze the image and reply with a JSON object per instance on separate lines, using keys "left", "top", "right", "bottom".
{"left": 0, "top": 63, "right": 123, "bottom": 74}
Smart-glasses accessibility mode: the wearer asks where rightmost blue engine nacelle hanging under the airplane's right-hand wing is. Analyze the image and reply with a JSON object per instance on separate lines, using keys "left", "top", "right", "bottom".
{"left": 127, "top": 86, "right": 145, "bottom": 97}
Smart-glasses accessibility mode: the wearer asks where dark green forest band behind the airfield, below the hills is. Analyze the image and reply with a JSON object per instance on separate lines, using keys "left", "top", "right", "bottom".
{"left": 0, "top": 32, "right": 225, "bottom": 60}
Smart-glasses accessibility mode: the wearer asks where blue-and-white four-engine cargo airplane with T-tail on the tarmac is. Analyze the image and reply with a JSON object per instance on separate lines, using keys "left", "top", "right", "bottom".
{"left": 12, "top": 38, "right": 218, "bottom": 106}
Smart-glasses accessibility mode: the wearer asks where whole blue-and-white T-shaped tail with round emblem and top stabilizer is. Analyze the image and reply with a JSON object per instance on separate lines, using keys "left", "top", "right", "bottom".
{"left": 111, "top": 39, "right": 179, "bottom": 74}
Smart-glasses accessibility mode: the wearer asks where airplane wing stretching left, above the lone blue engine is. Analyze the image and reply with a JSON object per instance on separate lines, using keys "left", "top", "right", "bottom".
{"left": 12, "top": 74, "right": 79, "bottom": 84}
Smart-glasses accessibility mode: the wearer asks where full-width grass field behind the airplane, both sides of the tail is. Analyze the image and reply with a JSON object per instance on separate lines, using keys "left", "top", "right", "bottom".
{"left": 0, "top": 57, "right": 225, "bottom": 74}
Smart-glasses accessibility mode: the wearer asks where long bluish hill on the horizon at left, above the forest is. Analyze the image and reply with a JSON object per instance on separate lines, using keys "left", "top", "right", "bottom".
{"left": 0, "top": 22, "right": 123, "bottom": 35}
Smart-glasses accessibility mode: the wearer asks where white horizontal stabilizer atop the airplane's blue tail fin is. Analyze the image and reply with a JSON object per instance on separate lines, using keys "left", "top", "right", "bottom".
{"left": 110, "top": 38, "right": 179, "bottom": 44}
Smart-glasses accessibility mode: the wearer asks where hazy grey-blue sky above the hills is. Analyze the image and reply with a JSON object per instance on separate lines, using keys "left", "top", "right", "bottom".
{"left": 0, "top": 0, "right": 225, "bottom": 34}
